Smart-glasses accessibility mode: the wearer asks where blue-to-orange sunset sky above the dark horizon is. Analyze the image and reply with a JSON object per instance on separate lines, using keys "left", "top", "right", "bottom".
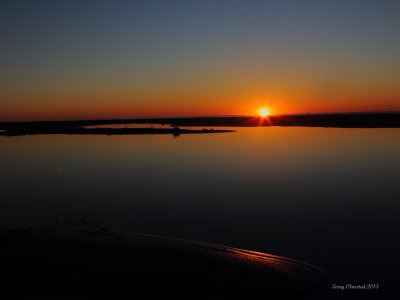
{"left": 0, "top": 0, "right": 400, "bottom": 121}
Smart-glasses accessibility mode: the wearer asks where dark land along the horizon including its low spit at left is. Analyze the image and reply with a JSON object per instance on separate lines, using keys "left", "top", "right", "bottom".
{"left": 0, "top": 112, "right": 400, "bottom": 136}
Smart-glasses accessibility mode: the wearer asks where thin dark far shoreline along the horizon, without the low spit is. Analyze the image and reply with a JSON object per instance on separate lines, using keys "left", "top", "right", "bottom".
{"left": 0, "top": 112, "right": 400, "bottom": 130}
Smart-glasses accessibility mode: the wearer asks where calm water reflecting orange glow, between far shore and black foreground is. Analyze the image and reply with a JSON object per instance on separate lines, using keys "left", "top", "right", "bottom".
{"left": 0, "top": 127, "right": 400, "bottom": 298}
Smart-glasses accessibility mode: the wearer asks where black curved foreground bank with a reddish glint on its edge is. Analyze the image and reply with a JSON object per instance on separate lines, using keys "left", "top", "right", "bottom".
{"left": 0, "top": 220, "right": 331, "bottom": 300}
